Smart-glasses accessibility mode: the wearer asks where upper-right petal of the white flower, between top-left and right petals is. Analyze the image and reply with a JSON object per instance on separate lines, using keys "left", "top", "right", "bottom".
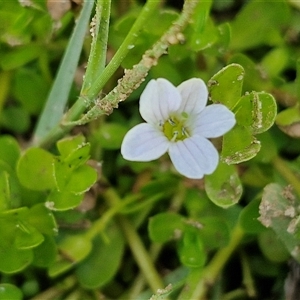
{"left": 177, "top": 78, "right": 208, "bottom": 115}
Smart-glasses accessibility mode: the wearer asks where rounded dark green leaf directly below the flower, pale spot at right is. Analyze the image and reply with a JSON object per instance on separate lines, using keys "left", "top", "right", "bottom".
{"left": 148, "top": 213, "right": 185, "bottom": 243}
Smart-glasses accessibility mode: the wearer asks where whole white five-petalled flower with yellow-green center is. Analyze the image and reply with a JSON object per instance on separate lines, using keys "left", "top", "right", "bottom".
{"left": 121, "top": 78, "right": 235, "bottom": 179}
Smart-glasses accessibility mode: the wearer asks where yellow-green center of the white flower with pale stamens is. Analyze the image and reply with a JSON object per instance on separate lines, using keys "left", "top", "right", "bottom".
{"left": 162, "top": 117, "right": 190, "bottom": 142}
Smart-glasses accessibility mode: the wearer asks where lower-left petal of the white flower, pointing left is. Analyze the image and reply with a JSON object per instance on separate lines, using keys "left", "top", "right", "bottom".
{"left": 121, "top": 123, "right": 170, "bottom": 161}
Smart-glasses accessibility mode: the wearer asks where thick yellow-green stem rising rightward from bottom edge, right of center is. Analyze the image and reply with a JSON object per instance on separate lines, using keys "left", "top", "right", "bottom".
{"left": 178, "top": 225, "right": 243, "bottom": 300}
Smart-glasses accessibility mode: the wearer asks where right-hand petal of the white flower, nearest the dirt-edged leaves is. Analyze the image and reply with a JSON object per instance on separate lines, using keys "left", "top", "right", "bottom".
{"left": 192, "top": 104, "right": 235, "bottom": 138}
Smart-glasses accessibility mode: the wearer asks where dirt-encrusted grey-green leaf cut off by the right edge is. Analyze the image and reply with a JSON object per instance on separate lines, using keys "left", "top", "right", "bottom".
{"left": 259, "top": 183, "right": 300, "bottom": 262}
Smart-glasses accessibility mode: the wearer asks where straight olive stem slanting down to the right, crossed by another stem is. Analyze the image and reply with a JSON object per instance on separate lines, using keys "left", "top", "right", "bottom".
{"left": 104, "top": 189, "right": 164, "bottom": 292}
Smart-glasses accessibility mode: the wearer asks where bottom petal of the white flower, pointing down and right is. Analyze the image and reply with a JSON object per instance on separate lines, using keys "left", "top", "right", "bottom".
{"left": 169, "top": 136, "right": 219, "bottom": 179}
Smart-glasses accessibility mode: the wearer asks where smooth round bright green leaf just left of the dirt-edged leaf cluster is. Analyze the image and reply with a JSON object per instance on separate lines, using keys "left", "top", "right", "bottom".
{"left": 17, "top": 148, "right": 55, "bottom": 191}
